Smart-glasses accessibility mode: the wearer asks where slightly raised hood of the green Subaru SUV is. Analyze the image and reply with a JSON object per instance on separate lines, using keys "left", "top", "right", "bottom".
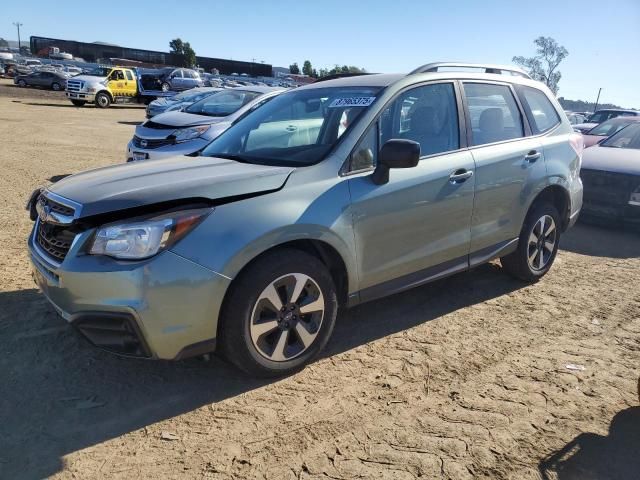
{"left": 48, "top": 157, "right": 294, "bottom": 217}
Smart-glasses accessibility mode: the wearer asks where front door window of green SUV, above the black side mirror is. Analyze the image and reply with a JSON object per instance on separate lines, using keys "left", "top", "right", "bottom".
{"left": 380, "top": 83, "right": 460, "bottom": 157}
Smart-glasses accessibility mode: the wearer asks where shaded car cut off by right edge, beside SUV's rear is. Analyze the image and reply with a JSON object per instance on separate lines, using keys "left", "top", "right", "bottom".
{"left": 580, "top": 122, "right": 640, "bottom": 225}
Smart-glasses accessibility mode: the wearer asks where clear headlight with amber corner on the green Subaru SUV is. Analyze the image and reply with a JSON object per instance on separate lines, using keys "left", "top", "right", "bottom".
{"left": 89, "top": 208, "right": 213, "bottom": 260}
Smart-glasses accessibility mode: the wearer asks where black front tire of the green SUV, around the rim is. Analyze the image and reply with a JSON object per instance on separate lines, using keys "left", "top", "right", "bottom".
{"left": 217, "top": 249, "right": 338, "bottom": 377}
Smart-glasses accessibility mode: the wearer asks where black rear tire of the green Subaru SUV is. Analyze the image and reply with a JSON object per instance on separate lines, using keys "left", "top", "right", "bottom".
{"left": 500, "top": 202, "right": 561, "bottom": 282}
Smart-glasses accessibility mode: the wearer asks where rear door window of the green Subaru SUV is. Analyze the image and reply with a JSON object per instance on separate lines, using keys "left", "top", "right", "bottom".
{"left": 464, "top": 83, "right": 524, "bottom": 145}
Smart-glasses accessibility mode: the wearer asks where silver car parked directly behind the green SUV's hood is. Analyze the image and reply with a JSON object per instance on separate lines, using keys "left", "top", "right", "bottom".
{"left": 126, "top": 87, "right": 283, "bottom": 162}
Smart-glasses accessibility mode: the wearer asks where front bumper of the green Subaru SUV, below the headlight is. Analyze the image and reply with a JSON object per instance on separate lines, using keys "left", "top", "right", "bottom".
{"left": 28, "top": 232, "right": 230, "bottom": 360}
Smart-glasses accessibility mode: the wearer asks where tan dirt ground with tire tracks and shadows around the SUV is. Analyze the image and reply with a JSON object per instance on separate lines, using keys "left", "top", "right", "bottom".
{"left": 0, "top": 81, "right": 640, "bottom": 480}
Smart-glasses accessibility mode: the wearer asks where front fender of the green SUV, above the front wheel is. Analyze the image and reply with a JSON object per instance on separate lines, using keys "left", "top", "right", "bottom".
{"left": 172, "top": 179, "right": 358, "bottom": 293}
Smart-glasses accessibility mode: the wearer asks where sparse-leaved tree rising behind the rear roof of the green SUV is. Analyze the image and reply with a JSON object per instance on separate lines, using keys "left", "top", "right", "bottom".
{"left": 512, "top": 37, "right": 569, "bottom": 95}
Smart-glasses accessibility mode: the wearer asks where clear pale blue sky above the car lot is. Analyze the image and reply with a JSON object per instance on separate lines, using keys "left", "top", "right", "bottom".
{"left": 0, "top": 0, "right": 640, "bottom": 109}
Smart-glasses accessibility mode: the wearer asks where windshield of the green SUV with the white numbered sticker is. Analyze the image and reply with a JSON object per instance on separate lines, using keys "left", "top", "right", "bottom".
{"left": 202, "top": 87, "right": 380, "bottom": 166}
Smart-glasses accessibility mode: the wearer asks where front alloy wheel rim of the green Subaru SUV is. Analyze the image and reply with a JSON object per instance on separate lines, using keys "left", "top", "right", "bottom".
{"left": 249, "top": 273, "right": 325, "bottom": 362}
